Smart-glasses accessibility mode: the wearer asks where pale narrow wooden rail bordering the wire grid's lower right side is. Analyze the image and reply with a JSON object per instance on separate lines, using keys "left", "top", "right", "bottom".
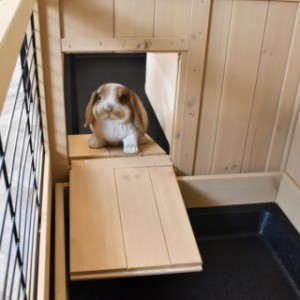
{"left": 37, "top": 152, "right": 53, "bottom": 300}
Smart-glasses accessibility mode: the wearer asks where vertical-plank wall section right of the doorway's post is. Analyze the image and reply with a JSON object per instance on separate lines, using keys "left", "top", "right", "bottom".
{"left": 194, "top": 0, "right": 300, "bottom": 174}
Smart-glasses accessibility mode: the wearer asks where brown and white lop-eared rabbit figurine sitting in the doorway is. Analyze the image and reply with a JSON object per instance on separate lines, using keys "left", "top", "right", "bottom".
{"left": 84, "top": 83, "right": 148, "bottom": 154}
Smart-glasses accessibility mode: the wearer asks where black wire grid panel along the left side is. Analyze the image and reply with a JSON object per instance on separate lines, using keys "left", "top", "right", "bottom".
{"left": 0, "top": 16, "right": 45, "bottom": 299}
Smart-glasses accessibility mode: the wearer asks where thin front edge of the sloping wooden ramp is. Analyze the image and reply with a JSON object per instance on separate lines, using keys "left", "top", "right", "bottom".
{"left": 71, "top": 264, "right": 203, "bottom": 281}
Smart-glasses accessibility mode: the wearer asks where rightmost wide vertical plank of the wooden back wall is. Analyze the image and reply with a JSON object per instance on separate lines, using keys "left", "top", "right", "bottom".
{"left": 242, "top": 1, "right": 298, "bottom": 172}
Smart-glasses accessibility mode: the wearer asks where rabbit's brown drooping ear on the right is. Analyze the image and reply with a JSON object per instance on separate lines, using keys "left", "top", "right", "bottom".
{"left": 129, "top": 91, "right": 148, "bottom": 133}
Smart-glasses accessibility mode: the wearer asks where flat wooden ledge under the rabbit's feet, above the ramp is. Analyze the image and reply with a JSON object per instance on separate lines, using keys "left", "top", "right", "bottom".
{"left": 68, "top": 134, "right": 166, "bottom": 160}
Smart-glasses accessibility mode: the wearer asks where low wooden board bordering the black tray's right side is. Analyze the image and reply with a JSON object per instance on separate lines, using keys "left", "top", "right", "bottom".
{"left": 276, "top": 172, "right": 300, "bottom": 233}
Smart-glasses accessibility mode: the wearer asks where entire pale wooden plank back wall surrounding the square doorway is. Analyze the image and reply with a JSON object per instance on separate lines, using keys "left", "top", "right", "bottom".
{"left": 40, "top": 0, "right": 300, "bottom": 178}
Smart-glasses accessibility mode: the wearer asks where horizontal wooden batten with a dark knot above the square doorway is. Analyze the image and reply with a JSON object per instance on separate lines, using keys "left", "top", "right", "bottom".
{"left": 61, "top": 37, "right": 189, "bottom": 53}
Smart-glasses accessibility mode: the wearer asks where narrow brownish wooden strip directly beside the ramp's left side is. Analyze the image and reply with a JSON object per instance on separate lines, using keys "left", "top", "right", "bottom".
{"left": 54, "top": 183, "right": 68, "bottom": 300}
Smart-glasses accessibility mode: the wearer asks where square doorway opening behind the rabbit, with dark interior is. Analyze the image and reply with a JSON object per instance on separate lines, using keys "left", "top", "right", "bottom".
{"left": 64, "top": 53, "right": 179, "bottom": 154}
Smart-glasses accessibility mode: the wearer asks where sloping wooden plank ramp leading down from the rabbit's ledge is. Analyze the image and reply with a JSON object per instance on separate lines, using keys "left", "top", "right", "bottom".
{"left": 70, "top": 155, "right": 202, "bottom": 280}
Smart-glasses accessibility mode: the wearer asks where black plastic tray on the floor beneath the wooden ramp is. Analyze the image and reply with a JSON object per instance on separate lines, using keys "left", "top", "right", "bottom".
{"left": 69, "top": 204, "right": 300, "bottom": 300}
